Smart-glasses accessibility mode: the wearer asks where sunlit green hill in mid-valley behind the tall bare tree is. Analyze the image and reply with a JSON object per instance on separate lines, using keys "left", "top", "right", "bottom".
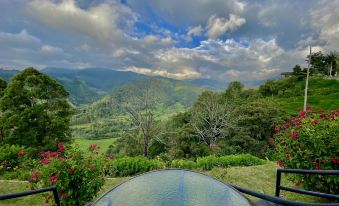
{"left": 72, "top": 77, "right": 202, "bottom": 138}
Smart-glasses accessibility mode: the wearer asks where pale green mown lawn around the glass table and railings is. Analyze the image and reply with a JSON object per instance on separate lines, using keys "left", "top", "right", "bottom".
{"left": 0, "top": 162, "right": 330, "bottom": 206}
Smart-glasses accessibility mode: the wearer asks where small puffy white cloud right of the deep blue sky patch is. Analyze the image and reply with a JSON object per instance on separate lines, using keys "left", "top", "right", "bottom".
{"left": 207, "top": 14, "right": 246, "bottom": 39}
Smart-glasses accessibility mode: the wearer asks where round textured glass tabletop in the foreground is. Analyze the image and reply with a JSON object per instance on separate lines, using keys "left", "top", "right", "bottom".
{"left": 93, "top": 170, "right": 251, "bottom": 206}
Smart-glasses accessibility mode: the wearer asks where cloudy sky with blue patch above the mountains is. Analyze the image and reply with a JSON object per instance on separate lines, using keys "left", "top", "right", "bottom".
{"left": 0, "top": 0, "right": 339, "bottom": 81}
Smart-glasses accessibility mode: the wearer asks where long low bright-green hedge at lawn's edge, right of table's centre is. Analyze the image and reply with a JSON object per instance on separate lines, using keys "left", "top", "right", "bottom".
{"left": 197, "top": 154, "right": 265, "bottom": 170}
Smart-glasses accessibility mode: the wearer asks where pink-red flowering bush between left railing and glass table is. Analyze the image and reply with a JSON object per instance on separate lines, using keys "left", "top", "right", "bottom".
{"left": 29, "top": 143, "right": 105, "bottom": 205}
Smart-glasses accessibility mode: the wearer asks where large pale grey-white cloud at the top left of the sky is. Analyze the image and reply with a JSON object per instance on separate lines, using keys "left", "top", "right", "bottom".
{"left": 27, "top": 0, "right": 131, "bottom": 40}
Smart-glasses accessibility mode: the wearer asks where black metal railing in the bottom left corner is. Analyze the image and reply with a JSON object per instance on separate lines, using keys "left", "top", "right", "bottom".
{"left": 0, "top": 186, "right": 61, "bottom": 206}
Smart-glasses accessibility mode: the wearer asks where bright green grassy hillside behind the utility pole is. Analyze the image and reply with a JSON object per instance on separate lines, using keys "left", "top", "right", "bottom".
{"left": 259, "top": 77, "right": 339, "bottom": 114}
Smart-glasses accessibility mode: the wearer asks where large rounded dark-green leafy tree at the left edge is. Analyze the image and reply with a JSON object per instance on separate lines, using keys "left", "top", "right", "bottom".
{"left": 0, "top": 67, "right": 73, "bottom": 150}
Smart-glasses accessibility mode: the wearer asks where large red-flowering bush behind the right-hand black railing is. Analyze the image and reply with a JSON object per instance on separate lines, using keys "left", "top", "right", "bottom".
{"left": 274, "top": 106, "right": 339, "bottom": 194}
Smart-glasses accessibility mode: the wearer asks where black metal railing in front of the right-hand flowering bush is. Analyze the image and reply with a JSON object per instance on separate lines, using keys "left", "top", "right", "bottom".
{"left": 275, "top": 169, "right": 339, "bottom": 201}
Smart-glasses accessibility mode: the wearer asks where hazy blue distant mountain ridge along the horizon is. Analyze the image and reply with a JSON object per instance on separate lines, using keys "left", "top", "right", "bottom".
{"left": 0, "top": 67, "right": 228, "bottom": 105}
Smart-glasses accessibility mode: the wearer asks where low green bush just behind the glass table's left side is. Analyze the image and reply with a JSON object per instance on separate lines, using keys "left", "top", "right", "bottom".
{"left": 106, "top": 157, "right": 165, "bottom": 177}
